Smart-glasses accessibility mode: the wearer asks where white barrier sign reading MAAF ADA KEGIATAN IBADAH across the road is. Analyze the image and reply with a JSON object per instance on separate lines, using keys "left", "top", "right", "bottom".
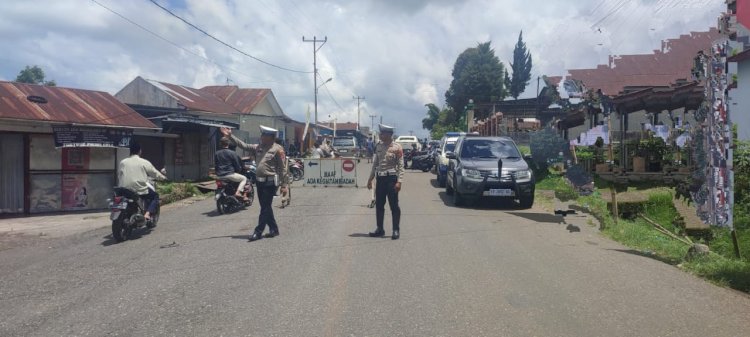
{"left": 303, "top": 158, "right": 359, "bottom": 187}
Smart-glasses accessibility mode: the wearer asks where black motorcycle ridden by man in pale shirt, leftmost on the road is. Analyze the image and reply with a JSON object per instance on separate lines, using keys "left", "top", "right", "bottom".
{"left": 108, "top": 183, "right": 161, "bottom": 242}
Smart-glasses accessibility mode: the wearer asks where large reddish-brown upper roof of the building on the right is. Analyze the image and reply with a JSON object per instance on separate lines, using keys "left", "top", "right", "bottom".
{"left": 567, "top": 28, "right": 721, "bottom": 96}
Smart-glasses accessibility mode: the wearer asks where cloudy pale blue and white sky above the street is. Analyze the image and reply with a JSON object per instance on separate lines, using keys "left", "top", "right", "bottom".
{"left": 0, "top": 0, "right": 726, "bottom": 136}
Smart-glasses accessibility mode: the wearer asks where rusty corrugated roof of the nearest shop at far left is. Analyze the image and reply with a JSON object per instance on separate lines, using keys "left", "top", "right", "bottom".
{"left": 0, "top": 81, "right": 158, "bottom": 129}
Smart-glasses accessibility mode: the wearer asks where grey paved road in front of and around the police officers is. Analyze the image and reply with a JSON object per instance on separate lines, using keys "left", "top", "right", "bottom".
{"left": 0, "top": 161, "right": 750, "bottom": 336}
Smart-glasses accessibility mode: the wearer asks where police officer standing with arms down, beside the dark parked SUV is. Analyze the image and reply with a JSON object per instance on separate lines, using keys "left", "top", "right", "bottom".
{"left": 367, "top": 124, "right": 404, "bottom": 240}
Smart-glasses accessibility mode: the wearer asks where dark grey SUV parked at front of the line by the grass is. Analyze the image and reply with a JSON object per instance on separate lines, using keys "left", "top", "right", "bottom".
{"left": 445, "top": 136, "right": 534, "bottom": 208}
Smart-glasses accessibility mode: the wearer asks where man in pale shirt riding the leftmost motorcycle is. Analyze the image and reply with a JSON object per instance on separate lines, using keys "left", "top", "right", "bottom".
{"left": 117, "top": 142, "right": 167, "bottom": 220}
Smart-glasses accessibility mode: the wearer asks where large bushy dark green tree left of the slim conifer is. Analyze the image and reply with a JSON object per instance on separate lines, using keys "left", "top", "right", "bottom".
{"left": 445, "top": 41, "right": 507, "bottom": 118}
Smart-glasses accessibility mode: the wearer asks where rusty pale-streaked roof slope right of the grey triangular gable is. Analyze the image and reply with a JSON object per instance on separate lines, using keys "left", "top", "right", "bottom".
{"left": 147, "top": 80, "right": 239, "bottom": 114}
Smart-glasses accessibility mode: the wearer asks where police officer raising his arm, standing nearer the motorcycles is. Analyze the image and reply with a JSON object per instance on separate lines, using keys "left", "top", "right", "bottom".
{"left": 221, "top": 125, "right": 287, "bottom": 241}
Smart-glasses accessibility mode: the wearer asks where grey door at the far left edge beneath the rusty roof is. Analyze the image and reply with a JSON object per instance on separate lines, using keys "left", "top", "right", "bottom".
{"left": 0, "top": 133, "right": 24, "bottom": 214}
